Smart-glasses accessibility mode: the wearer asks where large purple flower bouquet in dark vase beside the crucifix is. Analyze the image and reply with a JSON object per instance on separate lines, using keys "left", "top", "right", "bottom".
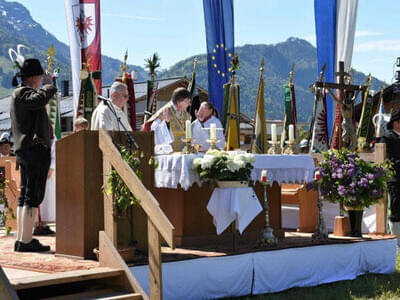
{"left": 317, "top": 148, "right": 393, "bottom": 237}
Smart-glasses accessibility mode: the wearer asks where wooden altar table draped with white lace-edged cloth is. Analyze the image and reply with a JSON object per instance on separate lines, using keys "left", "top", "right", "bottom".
{"left": 154, "top": 154, "right": 314, "bottom": 247}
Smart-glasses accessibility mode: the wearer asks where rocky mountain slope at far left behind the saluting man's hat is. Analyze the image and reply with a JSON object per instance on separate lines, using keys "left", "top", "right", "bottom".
{"left": 0, "top": 0, "right": 148, "bottom": 97}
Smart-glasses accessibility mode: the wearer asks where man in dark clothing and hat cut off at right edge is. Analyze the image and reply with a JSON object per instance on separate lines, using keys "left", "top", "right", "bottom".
{"left": 382, "top": 110, "right": 400, "bottom": 247}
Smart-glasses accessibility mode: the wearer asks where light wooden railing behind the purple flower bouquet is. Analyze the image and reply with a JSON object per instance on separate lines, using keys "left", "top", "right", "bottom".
{"left": 313, "top": 143, "right": 387, "bottom": 234}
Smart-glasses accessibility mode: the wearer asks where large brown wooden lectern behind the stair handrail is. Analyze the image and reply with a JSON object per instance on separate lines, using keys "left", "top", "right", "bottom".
{"left": 56, "top": 131, "right": 154, "bottom": 258}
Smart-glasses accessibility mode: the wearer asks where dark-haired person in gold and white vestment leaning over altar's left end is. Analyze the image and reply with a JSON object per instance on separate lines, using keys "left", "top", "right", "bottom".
{"left": 148, "top": 88, "right": 192, "bottom": 152}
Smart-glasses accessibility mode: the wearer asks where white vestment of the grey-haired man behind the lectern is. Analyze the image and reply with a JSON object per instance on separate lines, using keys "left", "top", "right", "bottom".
{"left": 90, "top": 101, "right": 132, "bottom": 131}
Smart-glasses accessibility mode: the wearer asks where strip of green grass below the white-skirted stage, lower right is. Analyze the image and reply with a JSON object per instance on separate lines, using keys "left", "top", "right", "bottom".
{"left": 234, "top": 255, "right": 400, "bottom": 300}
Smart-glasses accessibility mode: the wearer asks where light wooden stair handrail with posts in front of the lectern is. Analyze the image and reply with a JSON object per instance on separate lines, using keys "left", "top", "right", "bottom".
{"left": 99, "top": 131, "right": 175, "bottom": 299}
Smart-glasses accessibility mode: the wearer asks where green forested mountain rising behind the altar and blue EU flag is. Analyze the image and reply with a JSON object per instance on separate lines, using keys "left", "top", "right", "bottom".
{"left": 160, "top": 38, "right": 382, "bottom": 122}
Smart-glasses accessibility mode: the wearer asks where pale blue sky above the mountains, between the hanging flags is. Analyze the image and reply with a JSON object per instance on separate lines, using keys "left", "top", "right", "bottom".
{"left": 10, "top": 0, "right": 400, "bottom": 83}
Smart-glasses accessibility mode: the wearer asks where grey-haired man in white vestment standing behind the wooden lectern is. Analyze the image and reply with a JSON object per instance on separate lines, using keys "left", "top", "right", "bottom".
{"left": 90, "top": 81, "right": 132, "bottom": 131}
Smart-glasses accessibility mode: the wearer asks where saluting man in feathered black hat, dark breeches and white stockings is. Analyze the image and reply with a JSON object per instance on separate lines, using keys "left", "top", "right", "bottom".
{"left": 10, "top": 59, "right": 57, "bottom": 252}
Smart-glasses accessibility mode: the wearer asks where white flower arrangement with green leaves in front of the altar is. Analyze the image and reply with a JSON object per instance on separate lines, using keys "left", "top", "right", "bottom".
{"left": 192, "top": 150, "right": 255, "bottom": 187}
